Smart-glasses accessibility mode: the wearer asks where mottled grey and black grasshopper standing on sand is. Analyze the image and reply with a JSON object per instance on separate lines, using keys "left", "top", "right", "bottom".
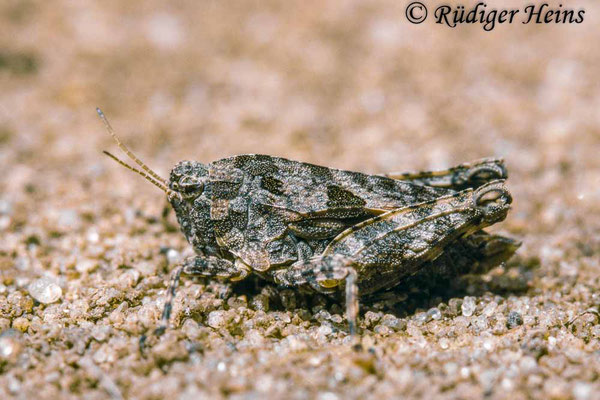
{"left": 97, "top": 109, "right": 518, "bottom": 335}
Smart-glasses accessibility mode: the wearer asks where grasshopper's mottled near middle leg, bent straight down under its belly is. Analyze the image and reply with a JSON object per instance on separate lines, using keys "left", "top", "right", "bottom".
{"left": 275, "top": 255, "right": 359, "bottom": 336}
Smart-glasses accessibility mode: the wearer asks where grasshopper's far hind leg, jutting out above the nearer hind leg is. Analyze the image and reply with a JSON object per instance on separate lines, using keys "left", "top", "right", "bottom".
{"left": 384, "top": 158, "right": 508, "bottom": 191}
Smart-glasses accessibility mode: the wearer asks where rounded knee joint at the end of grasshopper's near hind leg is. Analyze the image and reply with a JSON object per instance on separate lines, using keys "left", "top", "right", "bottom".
{"left": 473, "top": 180, "right": 512, "bottom": 226}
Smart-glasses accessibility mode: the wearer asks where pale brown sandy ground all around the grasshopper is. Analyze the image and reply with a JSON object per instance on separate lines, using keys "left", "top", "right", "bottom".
{"left": 0, "top": 0, "right": 600, "bottom": 400}
